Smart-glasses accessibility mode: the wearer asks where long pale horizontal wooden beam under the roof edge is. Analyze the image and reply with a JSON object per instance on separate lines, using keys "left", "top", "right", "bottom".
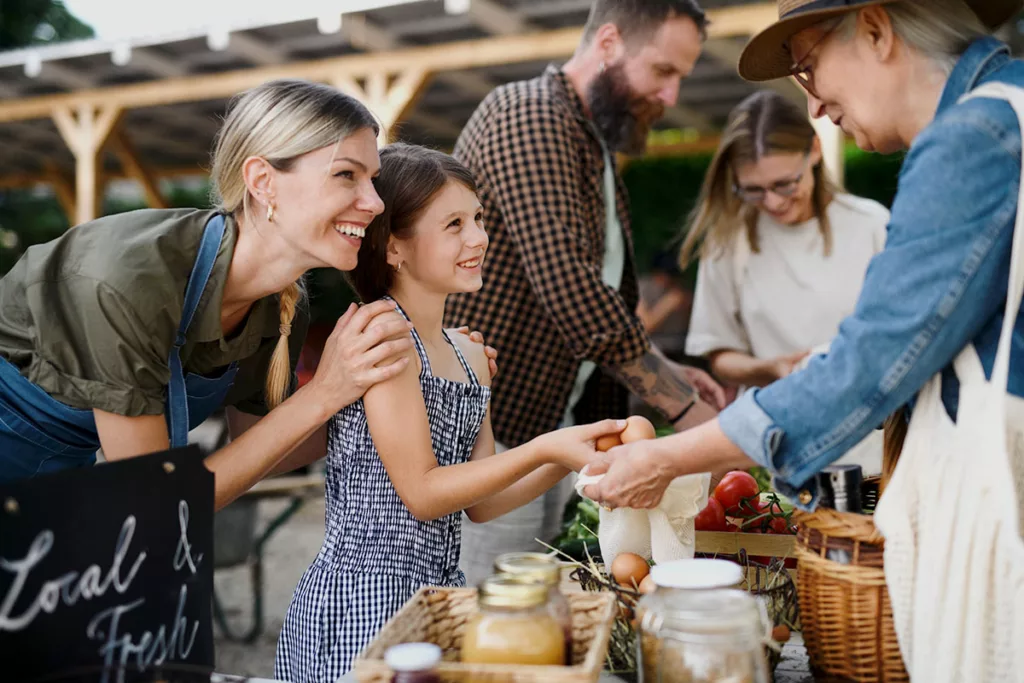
{"left": 0, "top": 2, "right": 777, "bottom": 122}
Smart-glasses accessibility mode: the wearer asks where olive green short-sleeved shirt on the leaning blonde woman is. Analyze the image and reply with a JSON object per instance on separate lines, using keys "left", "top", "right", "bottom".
{"left": 0, "top": 209, "right": 309, "bottom": 416}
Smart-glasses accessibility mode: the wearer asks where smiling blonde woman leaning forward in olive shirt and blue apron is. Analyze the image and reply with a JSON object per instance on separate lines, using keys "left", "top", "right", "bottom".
{"left": 0, "top": 80, "right": 491, "bottom": 508}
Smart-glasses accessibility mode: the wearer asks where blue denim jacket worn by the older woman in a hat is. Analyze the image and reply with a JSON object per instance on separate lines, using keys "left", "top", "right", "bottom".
{"left": 719, "top": 38, "right": 1024, "bottom": 510}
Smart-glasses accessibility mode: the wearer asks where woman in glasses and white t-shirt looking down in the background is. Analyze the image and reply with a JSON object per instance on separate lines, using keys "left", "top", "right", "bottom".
{"left": 680, "top": 90, "right": 889, "bottom": 474}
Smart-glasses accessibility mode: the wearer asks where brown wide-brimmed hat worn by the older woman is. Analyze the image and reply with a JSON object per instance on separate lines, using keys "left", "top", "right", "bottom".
{"left": 739, "top": 0, "right": 1024, "bottom": 81}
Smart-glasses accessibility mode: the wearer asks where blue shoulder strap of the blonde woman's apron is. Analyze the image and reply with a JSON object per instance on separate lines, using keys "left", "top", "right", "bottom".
{"left": 167, "top": 214, "right": 224, "bottom": 449}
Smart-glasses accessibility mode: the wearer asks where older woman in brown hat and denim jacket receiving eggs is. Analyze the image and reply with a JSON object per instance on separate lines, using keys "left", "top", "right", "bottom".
{"left": 586, "top": 0, "right": 1024, "bottom": 682}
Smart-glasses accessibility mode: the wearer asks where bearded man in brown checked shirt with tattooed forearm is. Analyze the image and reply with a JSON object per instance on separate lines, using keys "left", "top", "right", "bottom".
{"left": 445, "top": 0, "right": 725, "bottom": 585}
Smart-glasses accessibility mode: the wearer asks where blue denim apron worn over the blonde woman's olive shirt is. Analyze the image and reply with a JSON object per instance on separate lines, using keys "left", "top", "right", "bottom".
{"left": 0, "top": 214, "right": 238, "bottom": 483}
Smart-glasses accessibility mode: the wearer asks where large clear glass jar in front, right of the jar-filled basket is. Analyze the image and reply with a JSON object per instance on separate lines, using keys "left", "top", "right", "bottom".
{"left": 637, "top": 589, "right": 771, "bottom": 683}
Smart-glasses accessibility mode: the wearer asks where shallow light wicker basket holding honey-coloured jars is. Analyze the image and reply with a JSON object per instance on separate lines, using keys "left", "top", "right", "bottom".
{"left": 353, "top": 588, "right": 616, "bottom": 683}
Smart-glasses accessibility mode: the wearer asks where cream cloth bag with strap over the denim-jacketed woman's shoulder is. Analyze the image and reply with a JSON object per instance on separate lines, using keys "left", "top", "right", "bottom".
{"left": 874, "top": 84, "right": 1024, "bottom": 683}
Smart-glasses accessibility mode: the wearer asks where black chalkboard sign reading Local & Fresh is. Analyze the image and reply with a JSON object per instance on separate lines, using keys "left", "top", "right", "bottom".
{"left": 0, "top": 446, "right": 213, "bottom": 683}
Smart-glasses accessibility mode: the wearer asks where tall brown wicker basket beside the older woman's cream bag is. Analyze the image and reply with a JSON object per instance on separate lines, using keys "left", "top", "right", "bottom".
{"left": 794, "top": 509, "right": 910, "bottom": 683}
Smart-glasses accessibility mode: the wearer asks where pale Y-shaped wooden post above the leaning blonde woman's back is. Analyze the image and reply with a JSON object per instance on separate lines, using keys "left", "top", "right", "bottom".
{"left": 52, "top": 104, "right": 122, "bottom": 225}
